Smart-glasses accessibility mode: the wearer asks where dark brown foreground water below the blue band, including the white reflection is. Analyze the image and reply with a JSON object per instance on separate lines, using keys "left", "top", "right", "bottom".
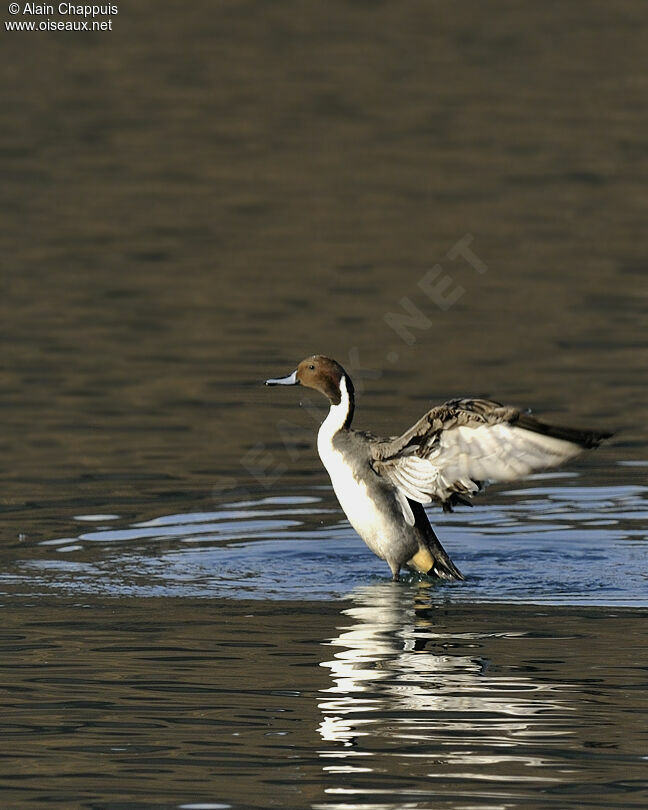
{"left": 1, "top": 592, "right": 647, "bottom": 809}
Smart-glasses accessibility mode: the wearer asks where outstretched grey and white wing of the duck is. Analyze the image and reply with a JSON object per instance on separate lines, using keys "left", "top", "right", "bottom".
{"left": 371, "top": 399, "right": 611, "bottom": 511}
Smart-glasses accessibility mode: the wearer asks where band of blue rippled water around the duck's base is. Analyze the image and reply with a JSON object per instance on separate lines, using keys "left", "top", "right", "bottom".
{"left": 0, "top": 472, "right": 648, "bottom": 607}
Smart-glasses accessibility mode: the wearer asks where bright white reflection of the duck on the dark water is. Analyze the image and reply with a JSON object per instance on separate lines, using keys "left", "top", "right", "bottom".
{"left": 316, "top": 583, "right": 569, "bottom": 810}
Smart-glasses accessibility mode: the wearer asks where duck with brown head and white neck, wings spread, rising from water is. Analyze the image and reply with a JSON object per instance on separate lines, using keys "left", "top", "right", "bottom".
{"left": 265, "top": 354, "right": 612, "bottom": 582}
